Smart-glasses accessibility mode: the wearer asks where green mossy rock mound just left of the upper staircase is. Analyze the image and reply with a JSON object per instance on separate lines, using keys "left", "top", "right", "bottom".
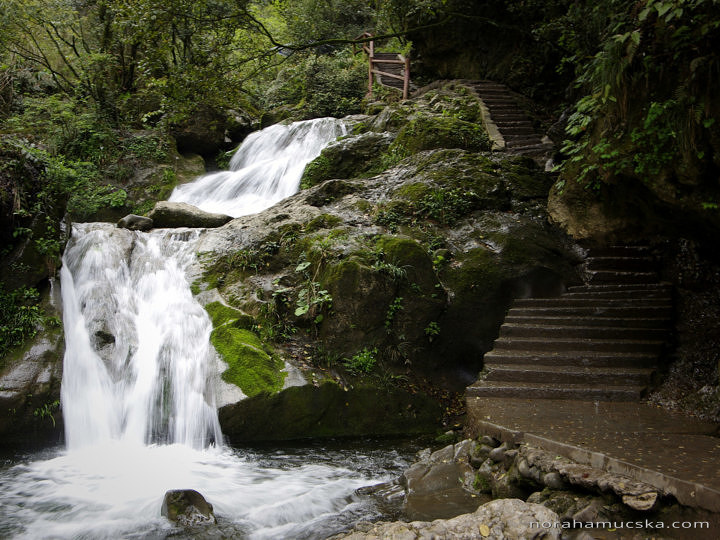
{"left": 389, "top": 116, "right": 490, "bottom": 156}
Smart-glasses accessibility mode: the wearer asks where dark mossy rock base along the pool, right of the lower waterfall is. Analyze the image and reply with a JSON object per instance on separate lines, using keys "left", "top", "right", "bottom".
{"left": 219, "top": 381, "right": 442, "bottom": 443}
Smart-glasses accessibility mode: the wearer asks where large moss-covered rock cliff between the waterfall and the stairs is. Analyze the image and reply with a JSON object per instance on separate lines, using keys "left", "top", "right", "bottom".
{"left": 188, "top": 85, "right": 579, "bottom": 439}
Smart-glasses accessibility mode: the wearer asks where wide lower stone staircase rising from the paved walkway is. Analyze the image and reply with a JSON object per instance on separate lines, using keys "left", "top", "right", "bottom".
{"left": 466, "top": 246, "right": 672, "bottom": 401}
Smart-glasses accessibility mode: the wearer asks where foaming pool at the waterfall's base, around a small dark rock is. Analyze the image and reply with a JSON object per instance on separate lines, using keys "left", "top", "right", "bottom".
{"left": 0, "top": 441, "right": 420, "bottom": 540}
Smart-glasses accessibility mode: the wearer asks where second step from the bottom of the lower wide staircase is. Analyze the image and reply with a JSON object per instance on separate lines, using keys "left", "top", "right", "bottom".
{"left": 482, "top": 364, "right": 655, "bottom": 386}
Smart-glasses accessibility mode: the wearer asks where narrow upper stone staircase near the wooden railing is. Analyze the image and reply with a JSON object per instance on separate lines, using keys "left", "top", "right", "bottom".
{"left": 462, "top": 81, "right": 552, "bottom": 155}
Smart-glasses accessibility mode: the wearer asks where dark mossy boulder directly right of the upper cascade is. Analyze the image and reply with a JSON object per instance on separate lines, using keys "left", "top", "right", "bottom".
{"left": 300, "top": 132, "right": 394, "bottom": 189}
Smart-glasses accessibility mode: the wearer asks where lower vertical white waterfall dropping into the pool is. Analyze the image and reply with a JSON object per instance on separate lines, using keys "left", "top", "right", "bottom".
{"left": 61, "top": 224, "right": 221, "bottom": 449}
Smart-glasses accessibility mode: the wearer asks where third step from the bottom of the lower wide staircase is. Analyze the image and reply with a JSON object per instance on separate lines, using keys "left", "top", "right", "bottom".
{"left": 483, "top": 349, "right": 657, "bottom": 368}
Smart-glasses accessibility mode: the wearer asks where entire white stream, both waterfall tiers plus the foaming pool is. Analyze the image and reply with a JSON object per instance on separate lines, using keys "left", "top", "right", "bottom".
{"left": 0, "top": 119, "right": 414, "bottom": 540}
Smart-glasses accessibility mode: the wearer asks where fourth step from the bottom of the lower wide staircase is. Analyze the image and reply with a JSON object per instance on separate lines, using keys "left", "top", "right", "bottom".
{"left": 495, "top": 337, "right": 663, "bottom": 354}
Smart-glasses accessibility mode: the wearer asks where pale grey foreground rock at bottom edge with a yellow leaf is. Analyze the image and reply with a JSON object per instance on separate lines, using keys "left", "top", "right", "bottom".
{"left": 332, "top": 499, "right": 562, "bottom": 540}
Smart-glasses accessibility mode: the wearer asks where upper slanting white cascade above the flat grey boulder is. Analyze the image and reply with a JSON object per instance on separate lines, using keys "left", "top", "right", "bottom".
{"left": 169, "top": 118, "right": 346, "bottom": 217}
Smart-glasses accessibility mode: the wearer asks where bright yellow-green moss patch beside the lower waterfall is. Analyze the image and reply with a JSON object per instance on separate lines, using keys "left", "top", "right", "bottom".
{"left": 210, "top": 324, "right": 287, "bottom": 396}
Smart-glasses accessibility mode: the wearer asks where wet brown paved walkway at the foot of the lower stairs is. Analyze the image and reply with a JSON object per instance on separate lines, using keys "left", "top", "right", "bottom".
{"left": 467, "top": 397, "right": 720, "bottom": 512}
